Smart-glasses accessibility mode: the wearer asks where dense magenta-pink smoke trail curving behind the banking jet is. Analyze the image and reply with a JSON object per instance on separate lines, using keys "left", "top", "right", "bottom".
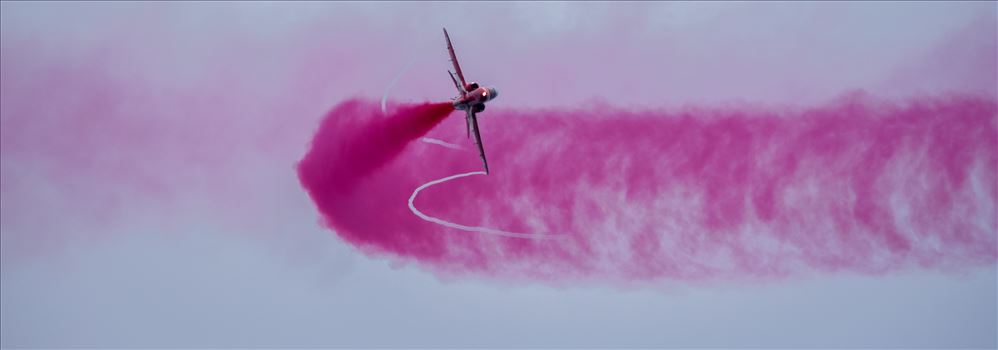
{"left": 298, "top": 94, "right": 998, "bottom": 281}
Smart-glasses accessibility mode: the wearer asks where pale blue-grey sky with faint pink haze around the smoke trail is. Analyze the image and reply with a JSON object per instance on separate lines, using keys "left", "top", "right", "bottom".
{"left": 0, "top": 2, "right": 998, "bottom": 348}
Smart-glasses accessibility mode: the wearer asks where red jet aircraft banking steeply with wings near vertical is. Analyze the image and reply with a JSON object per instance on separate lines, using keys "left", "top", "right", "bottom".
{"left": 444, "top": 28, "right": 499, "bottom": 174}
